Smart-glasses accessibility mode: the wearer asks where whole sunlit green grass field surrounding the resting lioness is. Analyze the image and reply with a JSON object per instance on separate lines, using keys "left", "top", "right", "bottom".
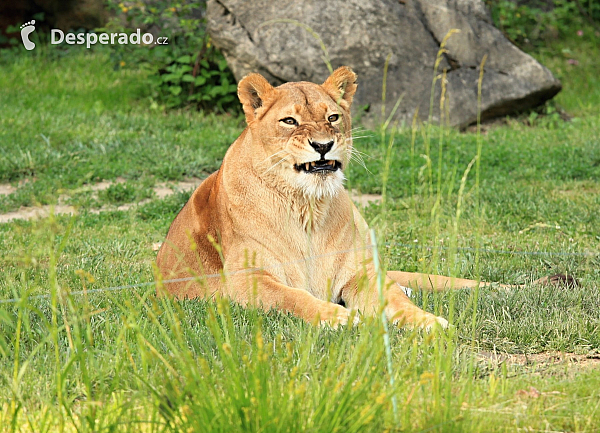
{"left": 0, "top": 36, "right": 600, "bottom": 432}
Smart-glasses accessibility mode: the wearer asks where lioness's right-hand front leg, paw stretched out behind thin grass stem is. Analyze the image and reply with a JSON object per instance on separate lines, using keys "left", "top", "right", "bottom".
{"left": 342, "top": 272, "right": 448, "bottom": 330}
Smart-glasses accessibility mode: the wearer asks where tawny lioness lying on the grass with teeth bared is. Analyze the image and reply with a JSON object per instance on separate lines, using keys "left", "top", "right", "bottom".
{"left": 157, "top": 67, "right": 516, "bottom": 328}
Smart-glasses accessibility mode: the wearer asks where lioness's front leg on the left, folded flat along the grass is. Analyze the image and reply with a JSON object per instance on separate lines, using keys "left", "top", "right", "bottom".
{"left": 225, "top": 271, "right": 350, "bottom": 327}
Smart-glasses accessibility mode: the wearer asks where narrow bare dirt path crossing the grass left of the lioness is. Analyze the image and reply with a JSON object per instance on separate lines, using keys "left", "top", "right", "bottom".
{"left": 0, "top": 177, "right": 203, "bottom": 224}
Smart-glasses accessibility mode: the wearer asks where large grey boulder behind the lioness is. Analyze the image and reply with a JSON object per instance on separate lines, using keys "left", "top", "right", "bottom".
{"left": 207, "top": 0, "right": 561, "bottom": 126}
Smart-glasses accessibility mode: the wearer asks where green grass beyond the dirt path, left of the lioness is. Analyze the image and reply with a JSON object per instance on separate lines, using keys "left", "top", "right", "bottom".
{"left": 0, "top": 49, "right": 241, "bottom": 212}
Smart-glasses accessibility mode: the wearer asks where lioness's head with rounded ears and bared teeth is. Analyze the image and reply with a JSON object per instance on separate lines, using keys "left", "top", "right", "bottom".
{"left": 238, "top": 67, "right": 356, "bottom": 199}
